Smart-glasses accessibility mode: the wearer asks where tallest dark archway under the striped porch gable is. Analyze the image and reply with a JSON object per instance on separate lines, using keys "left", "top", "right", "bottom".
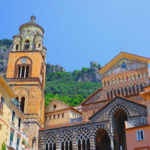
{"left": 113, "top": 109, "right": 127, "bottom": 150}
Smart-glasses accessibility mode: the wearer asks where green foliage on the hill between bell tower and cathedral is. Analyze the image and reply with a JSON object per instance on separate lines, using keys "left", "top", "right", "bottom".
{"left": 45, "top": 71, "right": 101, "bottom": 106}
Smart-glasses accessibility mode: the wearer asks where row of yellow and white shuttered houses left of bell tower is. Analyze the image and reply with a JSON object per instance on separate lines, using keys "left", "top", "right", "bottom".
{"left": 0, "top": 76, "right": 28, "bottom": 150}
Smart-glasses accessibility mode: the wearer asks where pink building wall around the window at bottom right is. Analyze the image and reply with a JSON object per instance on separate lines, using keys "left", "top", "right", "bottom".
{"left": 126, "top": 126, "right": 150, "bottom": 150}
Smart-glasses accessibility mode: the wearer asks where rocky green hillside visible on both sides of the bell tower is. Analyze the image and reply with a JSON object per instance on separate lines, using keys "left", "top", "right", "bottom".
{"left": 0, "top": 39, "right": 101, "bottom": 106}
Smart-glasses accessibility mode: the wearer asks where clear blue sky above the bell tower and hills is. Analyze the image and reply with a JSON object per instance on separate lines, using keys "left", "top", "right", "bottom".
{"left": 0, "top": 0, "right": 150, "bottom": 71}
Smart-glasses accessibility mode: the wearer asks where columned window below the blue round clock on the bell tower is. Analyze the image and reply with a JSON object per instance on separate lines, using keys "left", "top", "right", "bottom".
{"left": 18, "top": 65, "right": 29, "bottom": 78}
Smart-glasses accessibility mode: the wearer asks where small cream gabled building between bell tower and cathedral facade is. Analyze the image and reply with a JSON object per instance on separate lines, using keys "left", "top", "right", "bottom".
{"left": 45, "top": 99, "right": 81, "bottom": 128}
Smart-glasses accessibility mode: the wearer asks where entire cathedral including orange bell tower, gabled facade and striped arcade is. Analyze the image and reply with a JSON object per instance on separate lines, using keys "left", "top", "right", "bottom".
{"left": 6, "top": 16, "right": 150, "bottom": 150}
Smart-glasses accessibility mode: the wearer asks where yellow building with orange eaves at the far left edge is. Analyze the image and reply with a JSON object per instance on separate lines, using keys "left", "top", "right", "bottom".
{"left": 0, "top": 76, "right": 15, "bottom": 148}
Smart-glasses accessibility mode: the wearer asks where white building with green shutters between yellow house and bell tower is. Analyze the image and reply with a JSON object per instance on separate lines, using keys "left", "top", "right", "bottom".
{"left": 8, "top": 98, "right": 28, "bottom": 150}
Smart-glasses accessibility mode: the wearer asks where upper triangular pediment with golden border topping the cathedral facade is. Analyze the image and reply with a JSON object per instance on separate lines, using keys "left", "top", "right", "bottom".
{"left": 99, "top": 52, "right": 150, "bottom": 75}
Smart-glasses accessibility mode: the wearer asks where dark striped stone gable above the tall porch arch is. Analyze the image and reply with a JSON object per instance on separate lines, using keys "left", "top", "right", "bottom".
{"left": 89, "top": 96, "right": 147, "bottom": 122}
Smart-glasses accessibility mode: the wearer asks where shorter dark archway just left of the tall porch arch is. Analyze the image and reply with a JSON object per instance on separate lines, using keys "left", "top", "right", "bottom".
{"left": 96, "top": 129, "right": 111, "bottom": 150}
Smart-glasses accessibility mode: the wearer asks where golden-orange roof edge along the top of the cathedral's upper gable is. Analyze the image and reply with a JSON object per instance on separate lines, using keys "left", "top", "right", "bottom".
{"left": 99, "top": 52, "right": 150, "bottom": 74}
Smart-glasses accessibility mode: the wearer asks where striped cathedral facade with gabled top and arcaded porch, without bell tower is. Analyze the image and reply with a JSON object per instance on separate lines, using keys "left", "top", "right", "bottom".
{"left": 39, "top": 52, "right": 150, "bottom": 150}
